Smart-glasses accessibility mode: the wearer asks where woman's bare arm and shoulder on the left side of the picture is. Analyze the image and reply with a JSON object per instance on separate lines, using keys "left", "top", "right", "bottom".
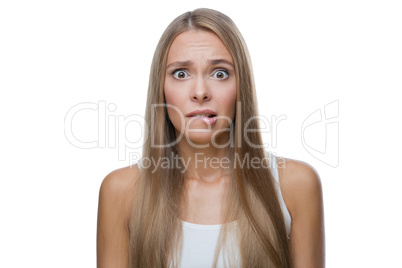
{"left": 97, "top": 167, "right": 138, "bottom": 268}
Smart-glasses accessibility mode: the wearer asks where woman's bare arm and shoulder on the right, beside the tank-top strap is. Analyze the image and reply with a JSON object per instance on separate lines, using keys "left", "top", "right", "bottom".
{"left": 280, "top": 160, "right": 325, "bottom": 268}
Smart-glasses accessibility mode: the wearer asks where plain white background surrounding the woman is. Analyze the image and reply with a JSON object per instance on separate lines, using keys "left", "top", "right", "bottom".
{"left": 0, "top": 0, "right": 402, "bottom": 268}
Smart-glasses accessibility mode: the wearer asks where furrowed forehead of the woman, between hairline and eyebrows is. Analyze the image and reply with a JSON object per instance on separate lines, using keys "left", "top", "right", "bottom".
{"left": 168, "top": 30, "right": 233, "bottom": 63}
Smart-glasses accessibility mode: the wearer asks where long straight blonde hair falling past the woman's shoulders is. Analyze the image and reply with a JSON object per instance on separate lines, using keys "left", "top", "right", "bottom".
{"left": 129, "top": 8, "right": 291, "bottom": 267}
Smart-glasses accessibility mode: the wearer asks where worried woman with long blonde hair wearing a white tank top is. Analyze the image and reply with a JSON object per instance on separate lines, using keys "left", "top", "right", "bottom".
{"left": 97, "top": 9, "right": 324, "bottom": 268}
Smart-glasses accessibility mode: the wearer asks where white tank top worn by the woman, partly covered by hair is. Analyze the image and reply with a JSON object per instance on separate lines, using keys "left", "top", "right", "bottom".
{"left": 137, "top": 152, "right": 292, "bottom": 268}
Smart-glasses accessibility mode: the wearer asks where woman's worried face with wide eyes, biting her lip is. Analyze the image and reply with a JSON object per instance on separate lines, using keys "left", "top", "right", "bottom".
{"left": 164, "top": 30, "right": 236, "bottom": 145}
